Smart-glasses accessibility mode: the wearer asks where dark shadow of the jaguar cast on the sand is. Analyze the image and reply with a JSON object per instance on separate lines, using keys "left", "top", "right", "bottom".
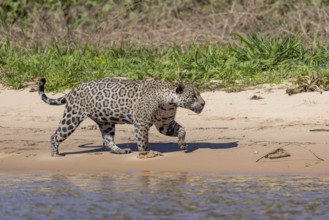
{"left": 64, "top": 141, "right": 239, "bottom": 155}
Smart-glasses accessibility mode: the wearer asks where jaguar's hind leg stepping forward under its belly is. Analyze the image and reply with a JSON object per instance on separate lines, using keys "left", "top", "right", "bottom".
{"left": 98, "top": 124, "right": 131, "bottom": 154}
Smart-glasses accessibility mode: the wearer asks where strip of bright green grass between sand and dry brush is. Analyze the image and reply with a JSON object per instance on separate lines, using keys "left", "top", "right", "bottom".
{"left": 0, "top": 34, "right": 329, "bottom": 91}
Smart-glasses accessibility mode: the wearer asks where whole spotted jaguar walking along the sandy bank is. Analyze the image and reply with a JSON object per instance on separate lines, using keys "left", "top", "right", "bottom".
{"left": 39, "top": 78, "right": 205, "bottom": 156}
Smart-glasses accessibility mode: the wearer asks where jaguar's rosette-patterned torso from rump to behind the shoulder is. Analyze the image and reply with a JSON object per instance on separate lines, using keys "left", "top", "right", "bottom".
{"left": 66, "top": 78, "right": 139, "bottom": 123}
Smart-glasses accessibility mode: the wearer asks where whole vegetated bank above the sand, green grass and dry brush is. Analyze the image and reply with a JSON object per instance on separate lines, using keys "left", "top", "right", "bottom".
{"left": 0, "top": 0, "right": 329, "bottom": 91}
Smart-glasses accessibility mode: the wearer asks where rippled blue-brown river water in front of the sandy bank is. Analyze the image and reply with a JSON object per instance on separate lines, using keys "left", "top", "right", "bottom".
{"left": 0, "top": 172, "right": 329, "bottom": 220}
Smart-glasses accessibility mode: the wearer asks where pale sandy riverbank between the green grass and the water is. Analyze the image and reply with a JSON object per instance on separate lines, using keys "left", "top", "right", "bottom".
{"left": 0, "top": 84, "right": 329, "bottom": 175}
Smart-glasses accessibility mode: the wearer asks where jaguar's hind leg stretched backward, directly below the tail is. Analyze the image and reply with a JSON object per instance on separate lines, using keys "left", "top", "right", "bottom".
{"left": 51, "top": 109, "right": 86, "bottom": 157}
